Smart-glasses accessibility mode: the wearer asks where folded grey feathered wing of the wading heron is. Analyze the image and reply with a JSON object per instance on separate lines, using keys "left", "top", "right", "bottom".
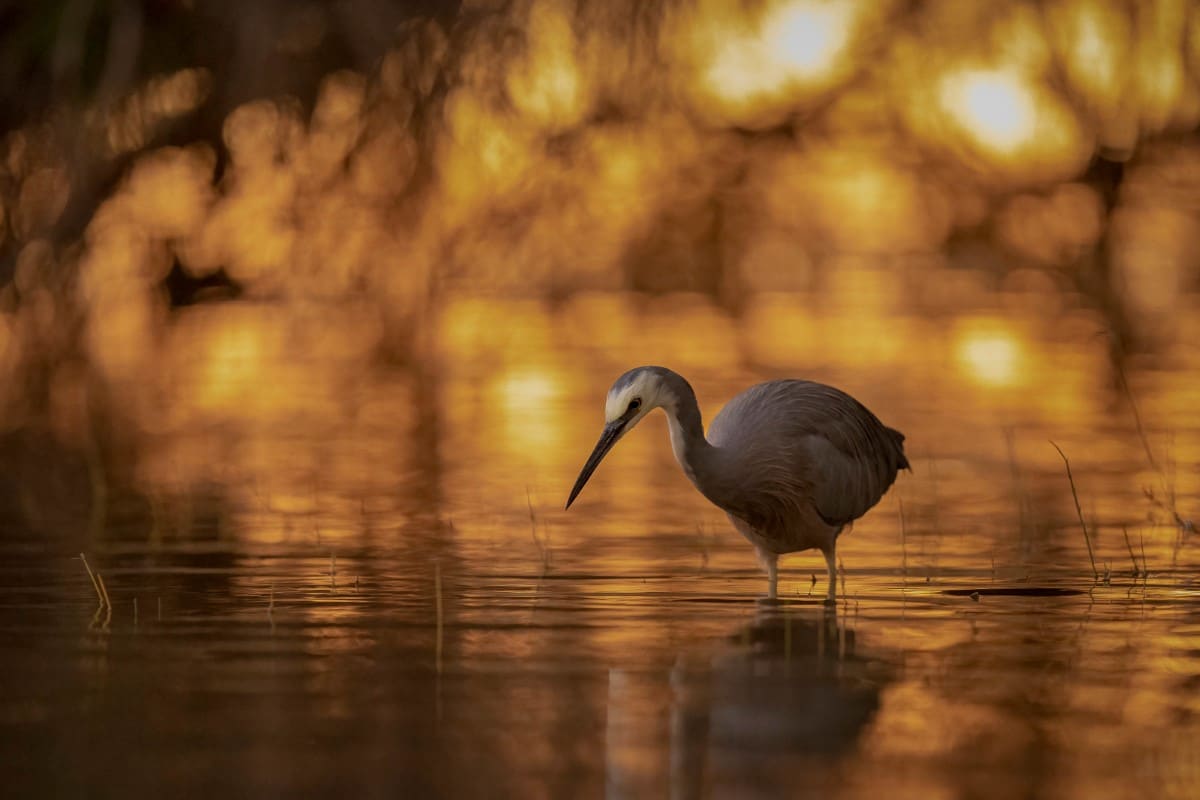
{"left": 709, "top": 380, "right": 908, "bottom": 527}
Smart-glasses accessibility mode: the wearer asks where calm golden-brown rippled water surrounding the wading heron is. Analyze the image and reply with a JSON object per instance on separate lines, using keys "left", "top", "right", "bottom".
{"left": 0, "top": 297, "right": 1200, "bottom": 799}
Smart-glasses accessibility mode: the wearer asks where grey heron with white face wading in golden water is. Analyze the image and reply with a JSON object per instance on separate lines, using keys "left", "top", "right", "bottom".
{"left": 566, "top": 366, "right": 910, "bottom": 602}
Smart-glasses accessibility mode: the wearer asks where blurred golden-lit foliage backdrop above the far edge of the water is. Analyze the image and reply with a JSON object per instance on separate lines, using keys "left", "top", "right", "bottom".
{"left": 0, "top": 0, "right": 1200, "bottom": 513}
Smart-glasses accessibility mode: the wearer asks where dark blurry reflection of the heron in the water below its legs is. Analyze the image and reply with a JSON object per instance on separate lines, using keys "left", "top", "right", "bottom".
{"left": 606, "top": 606, "right": 893, "bottom": 798}
